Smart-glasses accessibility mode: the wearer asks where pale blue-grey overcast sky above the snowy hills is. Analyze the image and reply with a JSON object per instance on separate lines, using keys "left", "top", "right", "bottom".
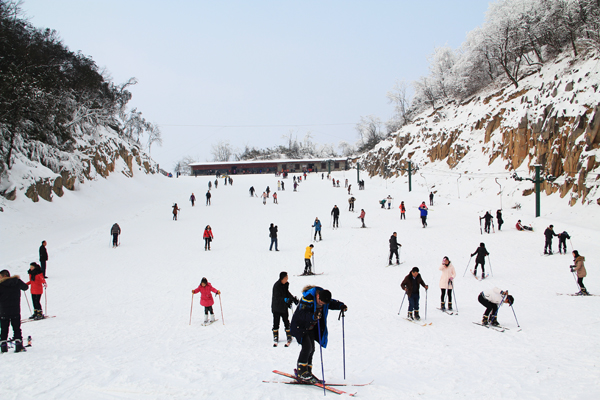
{"left": 23, "top": 0, "right": 488, "bottom": 170}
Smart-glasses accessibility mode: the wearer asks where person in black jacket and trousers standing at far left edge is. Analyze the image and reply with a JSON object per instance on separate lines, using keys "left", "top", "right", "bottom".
{"left": 0, "top": 269, "right": 29, "bottom": 353}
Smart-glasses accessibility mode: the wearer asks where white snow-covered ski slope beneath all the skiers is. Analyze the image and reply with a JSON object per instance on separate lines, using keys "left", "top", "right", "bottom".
{"left": 0, "top": 172, "right": 600, "bottom": 399}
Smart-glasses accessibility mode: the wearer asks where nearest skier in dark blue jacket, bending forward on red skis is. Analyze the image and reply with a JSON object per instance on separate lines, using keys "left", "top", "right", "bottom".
{"left": 290, "top": 286, "right": 348, "bottom": 383}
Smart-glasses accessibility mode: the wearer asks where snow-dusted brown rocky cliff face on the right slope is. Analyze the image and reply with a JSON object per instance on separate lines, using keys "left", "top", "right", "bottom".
{"left": 360, "top": 56, "right": 600, "bottom": 205}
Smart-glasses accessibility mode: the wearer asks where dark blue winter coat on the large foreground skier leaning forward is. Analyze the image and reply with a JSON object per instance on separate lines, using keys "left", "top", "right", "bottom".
{"left": 290, "top": 286, "right": 345, "bottom": 348}
